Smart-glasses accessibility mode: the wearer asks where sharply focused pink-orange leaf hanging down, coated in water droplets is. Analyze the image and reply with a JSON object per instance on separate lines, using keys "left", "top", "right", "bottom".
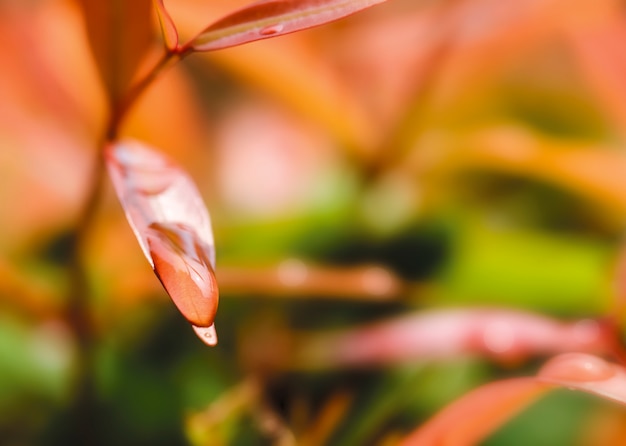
{"left": 105, "top": 140, "right": 218, "bottom": 345}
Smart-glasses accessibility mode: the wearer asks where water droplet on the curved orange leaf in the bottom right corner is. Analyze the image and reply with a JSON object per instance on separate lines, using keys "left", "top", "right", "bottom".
{"left": 539, "top": 353, "right": 615, "bottom": 382}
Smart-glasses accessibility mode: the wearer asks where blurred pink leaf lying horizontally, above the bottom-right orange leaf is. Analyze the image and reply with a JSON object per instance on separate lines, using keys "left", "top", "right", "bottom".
{"left": 295, "top": 309, "right": 607, "bottom": 368}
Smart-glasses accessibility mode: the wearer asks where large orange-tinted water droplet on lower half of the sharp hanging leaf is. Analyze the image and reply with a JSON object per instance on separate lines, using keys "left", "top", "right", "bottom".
{"left": 146, "top": 223, "right": 219, "bottom": 327}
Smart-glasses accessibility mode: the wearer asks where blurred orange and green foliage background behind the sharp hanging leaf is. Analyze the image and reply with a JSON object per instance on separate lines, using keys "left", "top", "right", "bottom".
{"left": 0, "top": 0, "right": 626, "bottom": 446}
